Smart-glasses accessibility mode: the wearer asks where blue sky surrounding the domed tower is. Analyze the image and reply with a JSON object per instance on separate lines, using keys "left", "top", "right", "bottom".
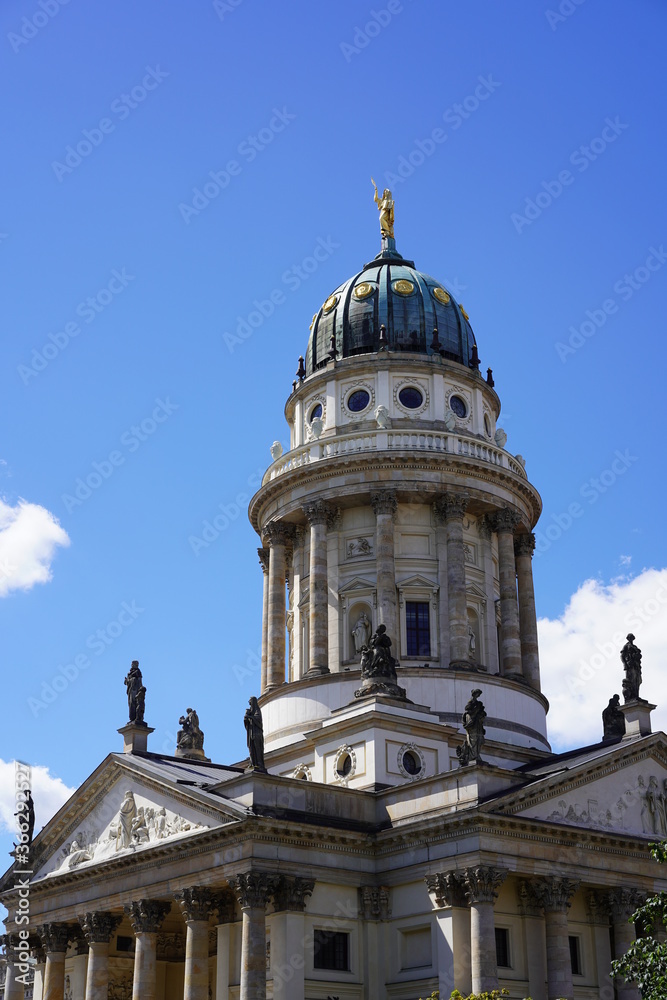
{"left": 0, "top": 0, "right": 667, "bottom": 856}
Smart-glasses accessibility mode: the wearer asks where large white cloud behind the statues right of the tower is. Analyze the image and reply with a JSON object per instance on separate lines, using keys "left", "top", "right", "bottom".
{"left": 538, "top": 569, "right": 667, "bottom": 751}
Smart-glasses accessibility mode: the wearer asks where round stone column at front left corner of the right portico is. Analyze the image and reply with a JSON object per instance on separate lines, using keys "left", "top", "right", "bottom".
{"left": 463, "top": 865, "right": 507, "bottom": 993}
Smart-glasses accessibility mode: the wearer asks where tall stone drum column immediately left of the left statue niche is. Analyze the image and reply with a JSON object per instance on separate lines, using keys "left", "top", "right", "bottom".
{"left": 303, "top": 500, "right": 332, "bottom": 676}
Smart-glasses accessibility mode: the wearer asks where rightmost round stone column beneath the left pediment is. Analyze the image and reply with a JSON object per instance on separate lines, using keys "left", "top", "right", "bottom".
{"left": 227, "top": 872, "right": 276, "bottom": 1000}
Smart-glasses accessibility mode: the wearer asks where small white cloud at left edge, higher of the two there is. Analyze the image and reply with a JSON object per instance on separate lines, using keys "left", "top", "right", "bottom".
{"left": 0, "top": 499, "right": 70, "bottom": 597}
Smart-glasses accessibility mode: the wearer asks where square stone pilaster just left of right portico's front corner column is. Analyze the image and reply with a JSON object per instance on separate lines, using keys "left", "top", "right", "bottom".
{"left": 426, "top": 871, "right": 472, "bottom": 997}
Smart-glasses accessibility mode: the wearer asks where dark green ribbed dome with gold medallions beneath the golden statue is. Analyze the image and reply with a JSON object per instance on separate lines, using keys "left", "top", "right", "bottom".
{"left": 306, "top": 238, "right": 477, "bottom": 375}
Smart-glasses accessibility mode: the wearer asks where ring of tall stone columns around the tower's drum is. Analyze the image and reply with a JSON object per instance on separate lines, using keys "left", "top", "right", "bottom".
{"left": 258, "top": 489, "right": 540, "bottom": 693}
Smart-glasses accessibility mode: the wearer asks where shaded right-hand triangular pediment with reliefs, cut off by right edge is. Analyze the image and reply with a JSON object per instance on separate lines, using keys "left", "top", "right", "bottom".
{"left": 500, "top": 748, "right": 667, "bottom": 840}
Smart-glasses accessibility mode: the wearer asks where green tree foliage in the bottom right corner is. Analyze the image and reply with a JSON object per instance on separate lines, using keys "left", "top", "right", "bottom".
{"left": 611, "top": 841, "right": 667, "bottom": 1000}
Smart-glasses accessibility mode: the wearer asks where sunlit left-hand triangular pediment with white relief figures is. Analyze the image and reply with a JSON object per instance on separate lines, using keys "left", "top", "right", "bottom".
{"left": 30, "top": 760, "right": 240, "bottom": 879}
